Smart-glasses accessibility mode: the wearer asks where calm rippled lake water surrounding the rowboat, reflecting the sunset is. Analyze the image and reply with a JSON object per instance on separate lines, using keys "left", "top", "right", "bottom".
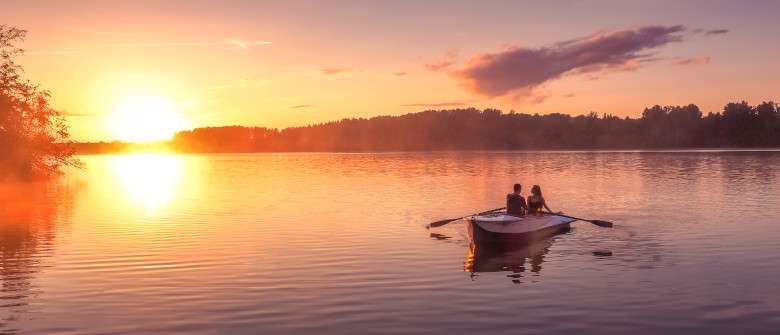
{"left": 0, "top": 152, "right": 780, "bottom": 334}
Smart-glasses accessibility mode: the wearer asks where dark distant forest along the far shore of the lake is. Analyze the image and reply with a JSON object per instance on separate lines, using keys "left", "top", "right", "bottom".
{"left": 77, "top": 101, "right": 780, "bottom": 152}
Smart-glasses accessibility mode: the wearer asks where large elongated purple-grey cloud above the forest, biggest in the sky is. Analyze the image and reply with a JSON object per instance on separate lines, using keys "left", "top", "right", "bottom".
{"left": 451, "top": 25, "right": 685, "bottom": 97}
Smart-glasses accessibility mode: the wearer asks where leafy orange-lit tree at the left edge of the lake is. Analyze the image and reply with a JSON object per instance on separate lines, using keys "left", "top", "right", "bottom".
{"left": 0, "top": 25, "right": 80, "bottom": 178}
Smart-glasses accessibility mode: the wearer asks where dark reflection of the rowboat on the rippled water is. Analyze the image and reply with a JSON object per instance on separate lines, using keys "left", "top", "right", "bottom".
{"left": 464, "top": 226, "right": 571, "bottom": 284}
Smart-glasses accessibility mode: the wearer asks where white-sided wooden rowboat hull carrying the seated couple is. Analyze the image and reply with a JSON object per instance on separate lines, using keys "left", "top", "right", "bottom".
{"left": 466, "top": 213, "right": 576, "bottom": 243}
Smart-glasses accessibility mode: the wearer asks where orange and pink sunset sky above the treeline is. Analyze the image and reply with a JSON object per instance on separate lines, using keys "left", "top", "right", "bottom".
{"left": 0, "top": 0, "right": 780, "bottom": 141}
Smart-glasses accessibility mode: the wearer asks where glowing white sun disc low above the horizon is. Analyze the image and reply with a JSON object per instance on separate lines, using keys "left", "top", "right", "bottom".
{"left": 108, "top": 95, "right": 187, "bottom": 142}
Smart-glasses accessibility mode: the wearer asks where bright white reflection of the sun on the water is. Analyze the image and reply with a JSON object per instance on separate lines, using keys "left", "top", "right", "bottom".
{"left": 111, "top": 154, "right": 182, "bottom": 213}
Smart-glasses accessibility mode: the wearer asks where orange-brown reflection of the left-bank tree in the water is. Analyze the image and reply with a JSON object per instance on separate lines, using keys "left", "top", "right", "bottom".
{"left": 0, "top": 183, "right": 73, "bottom": 334}
